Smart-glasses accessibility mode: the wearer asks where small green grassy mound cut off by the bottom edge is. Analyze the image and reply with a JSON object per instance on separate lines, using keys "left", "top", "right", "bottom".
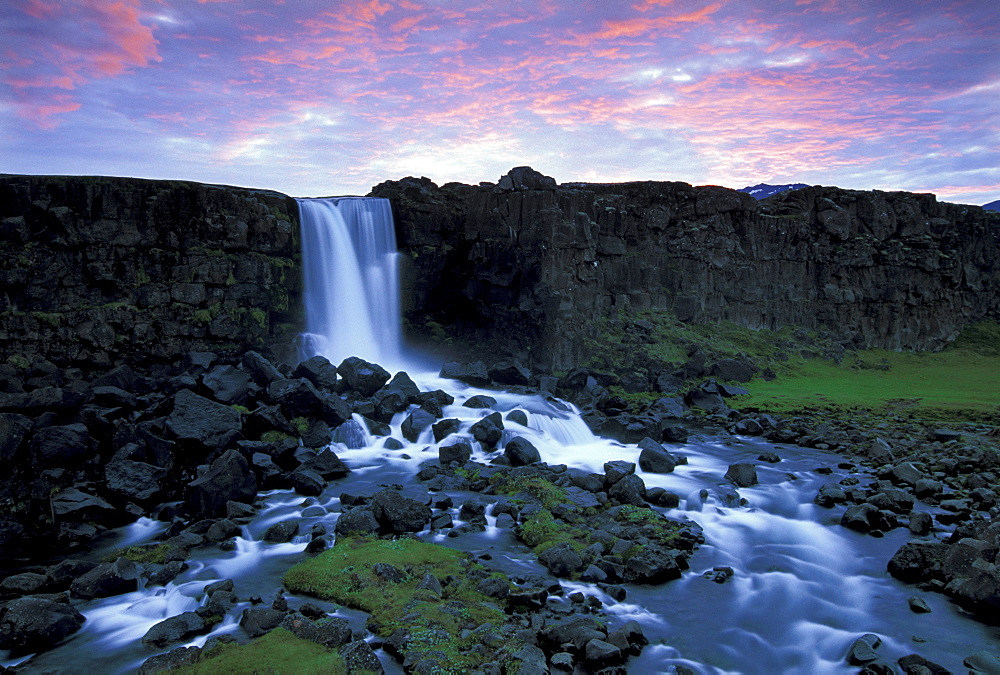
{"left": 171, "top": 628, "right": 347, "bottom": 675}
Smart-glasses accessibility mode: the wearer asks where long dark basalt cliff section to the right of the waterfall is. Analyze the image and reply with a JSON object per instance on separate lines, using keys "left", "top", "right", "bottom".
{"left": 372, "top": 168, "right": 1000, "bottom": 368}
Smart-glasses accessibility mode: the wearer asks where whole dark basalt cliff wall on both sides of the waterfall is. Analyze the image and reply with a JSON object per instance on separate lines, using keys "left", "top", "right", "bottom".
{"left": 0, "top": 167, "right": 1000, "bottom": 369}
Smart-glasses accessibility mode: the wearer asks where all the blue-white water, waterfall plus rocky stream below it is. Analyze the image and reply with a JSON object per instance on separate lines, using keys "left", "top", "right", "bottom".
{"left": 0, "top": 199, "right": 1000, "bottom": 673}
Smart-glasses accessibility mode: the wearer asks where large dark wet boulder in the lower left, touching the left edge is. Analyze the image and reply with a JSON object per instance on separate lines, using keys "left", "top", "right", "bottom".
{"left": 0, "top": 598, "right": 86, "bottom": 656}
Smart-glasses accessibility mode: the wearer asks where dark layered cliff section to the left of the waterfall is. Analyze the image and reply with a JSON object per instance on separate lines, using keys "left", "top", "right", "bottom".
{"left": 0, "top": 175, "right": 300, "bottom": 366}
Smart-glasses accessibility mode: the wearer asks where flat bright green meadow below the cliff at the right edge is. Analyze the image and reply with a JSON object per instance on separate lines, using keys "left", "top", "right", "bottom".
{"left": 738, "top": 349, "right": 1000, "bottom": 422}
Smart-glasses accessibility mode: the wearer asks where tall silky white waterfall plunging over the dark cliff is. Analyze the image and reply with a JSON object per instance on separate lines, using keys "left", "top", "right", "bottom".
{"left": 297, "top": 197, "right": 403, "bottom": 368}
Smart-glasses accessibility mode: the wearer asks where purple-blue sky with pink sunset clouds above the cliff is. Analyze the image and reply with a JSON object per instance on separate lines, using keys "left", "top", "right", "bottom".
{"left": 0, "top": 0, "right": 1000, "bottom": 204}
